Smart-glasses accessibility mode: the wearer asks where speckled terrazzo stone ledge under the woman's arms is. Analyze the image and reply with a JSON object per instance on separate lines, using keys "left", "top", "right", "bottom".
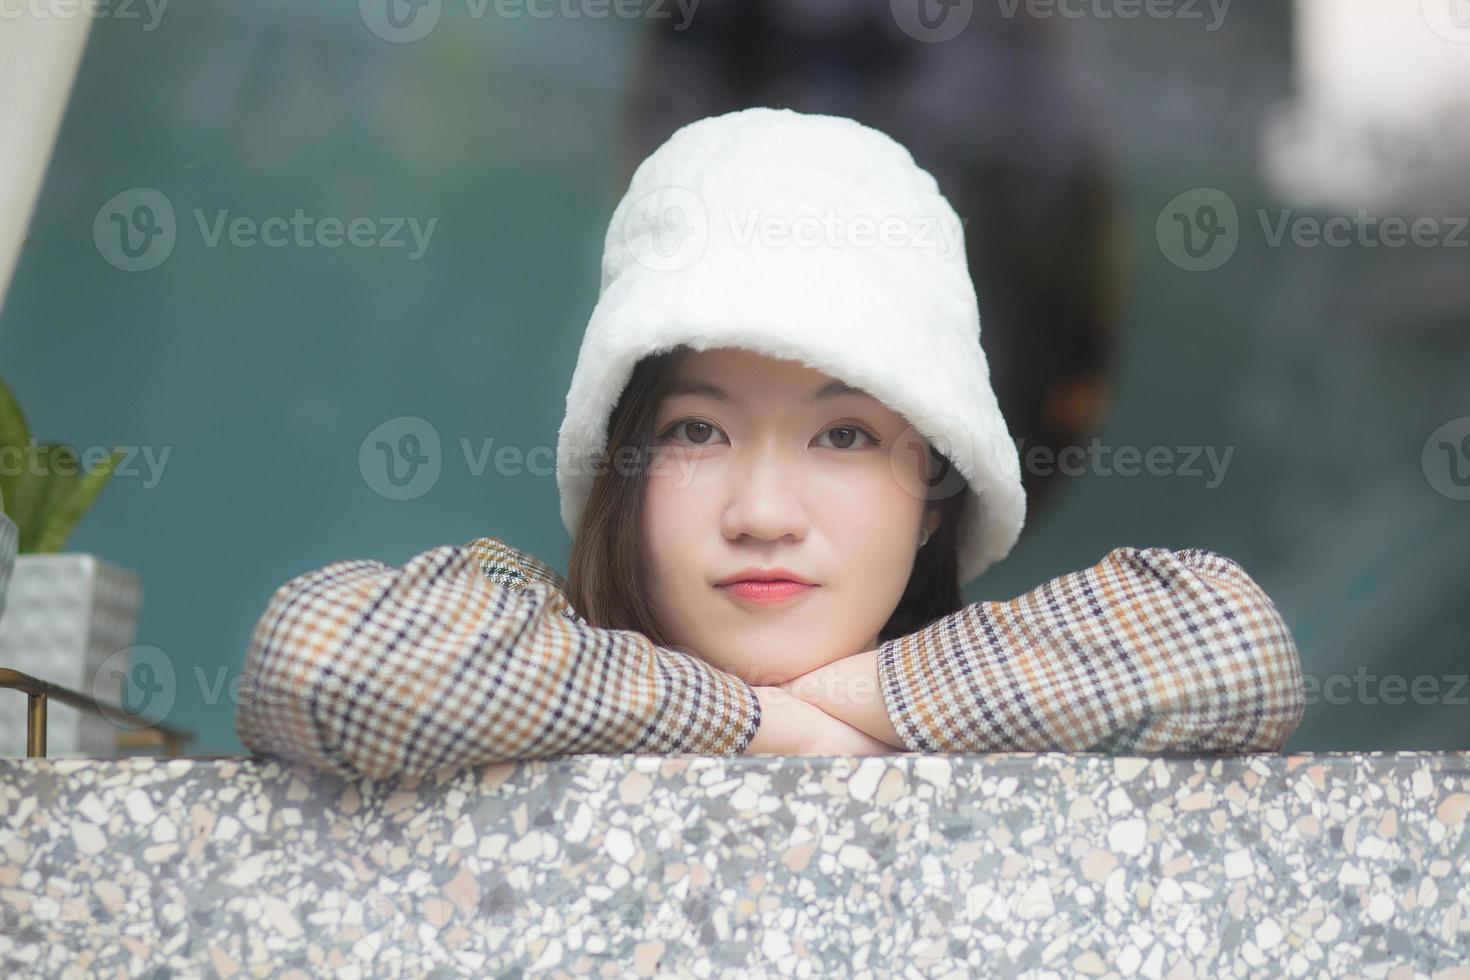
{"left": 0, "top": 752, "right": 1470, "bottom": 980}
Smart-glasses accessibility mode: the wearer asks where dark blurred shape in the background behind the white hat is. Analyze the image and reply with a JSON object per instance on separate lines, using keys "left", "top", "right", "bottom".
{"left": 619, "top": 0, "right": 1127, "bottom": 520}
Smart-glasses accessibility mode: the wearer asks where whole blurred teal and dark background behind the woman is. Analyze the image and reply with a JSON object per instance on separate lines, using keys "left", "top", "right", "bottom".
{"left": 0, "top": 0, "right": 1470, "bottom": 754}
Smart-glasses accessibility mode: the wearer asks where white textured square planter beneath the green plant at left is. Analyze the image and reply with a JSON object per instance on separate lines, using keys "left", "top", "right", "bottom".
{"left": 0, "top": 554, "right": 143, "bottom": 758}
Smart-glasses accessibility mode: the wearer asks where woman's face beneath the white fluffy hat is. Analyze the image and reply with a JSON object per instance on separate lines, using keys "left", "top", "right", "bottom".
{"left": 642, "top": 348, "right": 938, "bottom": 685}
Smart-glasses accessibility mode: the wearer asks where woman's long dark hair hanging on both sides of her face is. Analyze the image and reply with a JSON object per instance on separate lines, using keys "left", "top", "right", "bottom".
{"left": 567, "top": 345, "right": 969, "bottom": 652}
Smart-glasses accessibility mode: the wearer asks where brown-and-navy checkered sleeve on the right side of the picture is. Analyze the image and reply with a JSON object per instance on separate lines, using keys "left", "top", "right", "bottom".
{"left": 878, "top": 548, "right": 1305, "bottom": 754}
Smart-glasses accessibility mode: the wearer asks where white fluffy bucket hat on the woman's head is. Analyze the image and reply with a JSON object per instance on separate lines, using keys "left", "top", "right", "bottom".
{"left": 557, "top": 107, "right": 1026, "bottom": 585}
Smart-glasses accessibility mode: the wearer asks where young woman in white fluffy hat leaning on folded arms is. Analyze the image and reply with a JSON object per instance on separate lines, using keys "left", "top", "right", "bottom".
{"left": 237, "top": 109, "right": 1304, "bottom": 777}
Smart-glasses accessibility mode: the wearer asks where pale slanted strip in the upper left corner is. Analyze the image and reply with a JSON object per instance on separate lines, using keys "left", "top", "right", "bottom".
{"left": 0, "top": 13, "right": 91, "bottom": 315}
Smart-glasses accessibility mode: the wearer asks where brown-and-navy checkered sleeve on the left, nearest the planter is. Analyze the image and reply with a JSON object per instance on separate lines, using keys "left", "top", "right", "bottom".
{"left": 235, "top": 538, "right": 760, "bottom": 779}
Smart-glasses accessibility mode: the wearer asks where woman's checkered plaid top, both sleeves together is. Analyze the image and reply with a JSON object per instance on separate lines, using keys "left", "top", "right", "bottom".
{"left": 235, "top": 538, "right": 1305, "bottom": 779}
